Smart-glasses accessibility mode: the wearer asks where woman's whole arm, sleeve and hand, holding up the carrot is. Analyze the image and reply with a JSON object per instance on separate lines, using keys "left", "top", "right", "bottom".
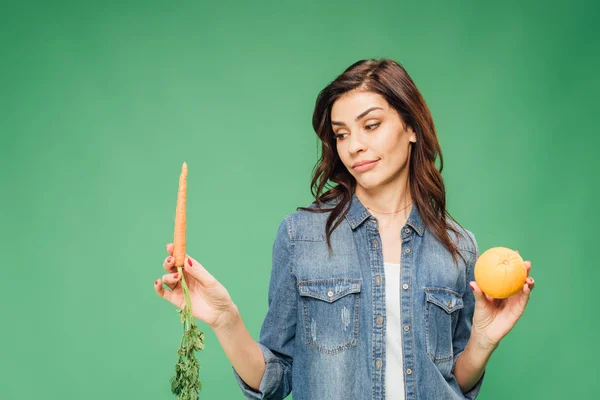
{"left": 154, "top": 219, "right": 297, "bottom": 400}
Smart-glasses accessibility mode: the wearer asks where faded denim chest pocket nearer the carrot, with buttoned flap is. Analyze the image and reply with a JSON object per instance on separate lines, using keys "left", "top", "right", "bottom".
{"left": 298, "top": 278, "right": 361, "bottom": 355}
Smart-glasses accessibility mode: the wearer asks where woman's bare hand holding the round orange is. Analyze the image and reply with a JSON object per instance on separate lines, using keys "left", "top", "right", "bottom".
{"left": 470, "top": 253, "right": 535, "bottom": 348}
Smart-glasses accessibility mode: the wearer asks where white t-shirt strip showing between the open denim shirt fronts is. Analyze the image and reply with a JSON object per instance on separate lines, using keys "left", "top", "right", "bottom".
{"left": 383, "top": 262, "right": 404, "bottom": 400}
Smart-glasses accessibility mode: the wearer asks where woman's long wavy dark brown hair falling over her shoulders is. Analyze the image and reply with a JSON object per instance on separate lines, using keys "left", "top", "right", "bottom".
{"left": 298, "top": 59, "right": 462, "bottom": 261}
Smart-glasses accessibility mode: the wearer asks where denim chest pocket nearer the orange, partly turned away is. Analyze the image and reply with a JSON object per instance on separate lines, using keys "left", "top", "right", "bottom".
{"left": 425, "top": 288, "right": 464, "bottom": 367}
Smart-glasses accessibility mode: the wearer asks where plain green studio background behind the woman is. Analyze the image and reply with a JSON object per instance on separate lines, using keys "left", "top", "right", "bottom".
{"left": 0, "top": 1, "right": 600, "bottom": 400}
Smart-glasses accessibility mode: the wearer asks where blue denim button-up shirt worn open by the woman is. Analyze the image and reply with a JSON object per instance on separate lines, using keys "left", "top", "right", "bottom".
{"left": 234, "top": 195, "right": 483, "bottom": 400}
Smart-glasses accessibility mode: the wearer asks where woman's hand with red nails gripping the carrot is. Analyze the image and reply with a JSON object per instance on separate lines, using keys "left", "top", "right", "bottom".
{"left": 154, "top": 243, "right": 237, "bottom": 329}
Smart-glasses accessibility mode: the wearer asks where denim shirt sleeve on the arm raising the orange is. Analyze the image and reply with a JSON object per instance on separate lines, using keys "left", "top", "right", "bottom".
{"left": 452, "top": 231, "right": 485, "bottom": 400}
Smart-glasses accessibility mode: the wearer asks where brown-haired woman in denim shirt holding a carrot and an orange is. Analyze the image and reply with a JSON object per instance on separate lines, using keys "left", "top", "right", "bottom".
{"left": 155, "top": 59, "right": 534, "bottom": 400}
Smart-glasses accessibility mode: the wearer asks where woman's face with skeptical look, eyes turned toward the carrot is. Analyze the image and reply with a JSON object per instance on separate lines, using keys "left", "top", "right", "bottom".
{"left": 331, "top": 91, "right": 416, "bottom": 190}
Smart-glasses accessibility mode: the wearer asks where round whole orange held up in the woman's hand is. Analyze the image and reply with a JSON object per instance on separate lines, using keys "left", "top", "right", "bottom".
{"left": 474, "top": 247, "right": 527, "bottom": 299}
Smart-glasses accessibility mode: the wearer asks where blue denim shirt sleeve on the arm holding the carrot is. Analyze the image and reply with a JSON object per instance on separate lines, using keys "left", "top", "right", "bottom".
{"left": 233, "top": 215, "right": 298, "bottom": 400}
